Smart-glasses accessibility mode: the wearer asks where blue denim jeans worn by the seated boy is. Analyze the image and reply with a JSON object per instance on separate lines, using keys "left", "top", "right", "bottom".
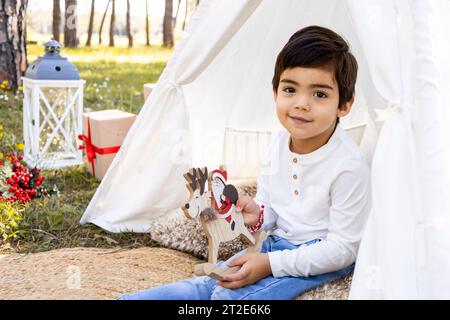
{"left": 118, "top": 236, "right": 354, "bottom": 300}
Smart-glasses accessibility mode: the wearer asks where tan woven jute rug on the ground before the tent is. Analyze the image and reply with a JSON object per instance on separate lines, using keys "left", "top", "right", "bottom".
{"left": 0, "top": 247, "right": 198, "bottom": 300}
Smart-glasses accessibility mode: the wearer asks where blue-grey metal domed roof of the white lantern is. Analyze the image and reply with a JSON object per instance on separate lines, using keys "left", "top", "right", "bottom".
{"left": 25, "top": 39, "right": 80, "bottom": 80}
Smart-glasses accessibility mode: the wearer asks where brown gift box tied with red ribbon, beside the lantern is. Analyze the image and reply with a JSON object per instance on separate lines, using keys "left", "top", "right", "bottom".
{"left": 79, "top": 109, "right": 136, "bottom": 179}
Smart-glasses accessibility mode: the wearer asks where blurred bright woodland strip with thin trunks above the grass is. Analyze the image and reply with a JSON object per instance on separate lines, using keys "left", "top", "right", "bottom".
{"left": 26, "top": 0, "right": 199, "bottom": 47}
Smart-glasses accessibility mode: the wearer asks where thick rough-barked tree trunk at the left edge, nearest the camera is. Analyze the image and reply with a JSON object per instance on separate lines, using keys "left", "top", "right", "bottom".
{"left": 0, "top": 0, "right": 27, "bottom": 90}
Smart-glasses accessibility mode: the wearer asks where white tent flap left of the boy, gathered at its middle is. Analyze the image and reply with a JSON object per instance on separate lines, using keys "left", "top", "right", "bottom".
{"left": 81, "top": 0, "right": 260, "bottom": 232}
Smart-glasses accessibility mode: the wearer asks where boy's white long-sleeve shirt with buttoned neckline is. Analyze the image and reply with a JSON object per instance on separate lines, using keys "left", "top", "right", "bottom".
{"left": 255, "top": 125, "right": 371, "bottom": 277}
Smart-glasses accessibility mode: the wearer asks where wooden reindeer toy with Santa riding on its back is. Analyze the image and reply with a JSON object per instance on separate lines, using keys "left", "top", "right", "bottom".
{"left": 182, "top": 166, "right": 266, "bottom": 280}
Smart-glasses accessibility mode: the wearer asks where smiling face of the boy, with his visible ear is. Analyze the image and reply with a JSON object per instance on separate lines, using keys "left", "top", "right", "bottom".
{"left": 274, "top": 67, "right": 353, "bottom": 144}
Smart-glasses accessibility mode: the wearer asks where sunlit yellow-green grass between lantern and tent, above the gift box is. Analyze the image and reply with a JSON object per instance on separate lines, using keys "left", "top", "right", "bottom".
{"left": 27, "top": 45, "right": 172, "bottom": 113}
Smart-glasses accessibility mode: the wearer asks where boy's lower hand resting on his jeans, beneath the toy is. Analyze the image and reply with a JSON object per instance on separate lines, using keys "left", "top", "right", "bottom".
{"left": 217, "top": 252, "right": 272, "bottom": 289}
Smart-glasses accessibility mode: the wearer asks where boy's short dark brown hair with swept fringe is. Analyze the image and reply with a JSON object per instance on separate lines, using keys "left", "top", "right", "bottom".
{"left": 272, "top": 26, "right": 358, "bottom": 108}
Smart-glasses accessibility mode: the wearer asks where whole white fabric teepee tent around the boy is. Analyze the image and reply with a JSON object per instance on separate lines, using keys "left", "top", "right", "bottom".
{"left": 81, "top": 0, "right": 450, "bottom": 299}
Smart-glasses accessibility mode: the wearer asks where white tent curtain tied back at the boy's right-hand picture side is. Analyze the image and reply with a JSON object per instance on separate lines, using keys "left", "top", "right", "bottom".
{"left": 350, "top": 0, "right": 450, "bottom": 299}
